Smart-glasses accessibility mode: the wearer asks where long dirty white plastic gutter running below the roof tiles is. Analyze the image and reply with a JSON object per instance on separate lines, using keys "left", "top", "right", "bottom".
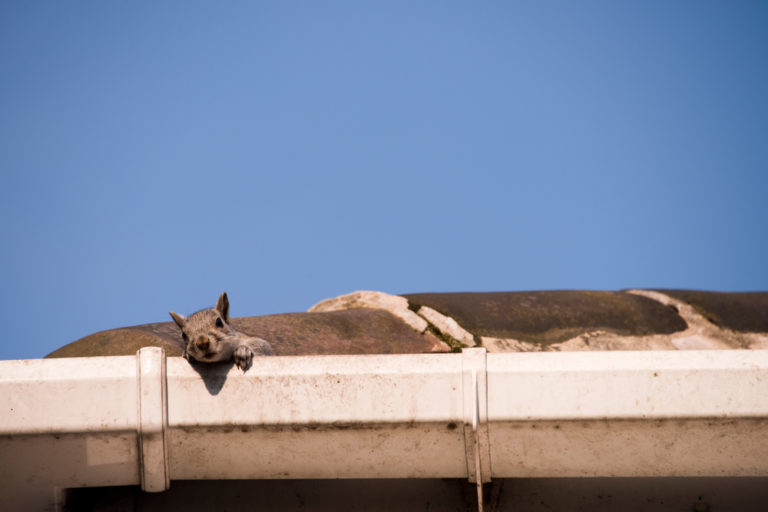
{"left": 0, "top": 348, "right": 768, "bottom": 510}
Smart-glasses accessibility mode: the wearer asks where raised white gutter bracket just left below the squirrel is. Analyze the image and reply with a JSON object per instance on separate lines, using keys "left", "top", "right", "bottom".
{"left": 136, "top": 347, "right": 171, "bottom": 492}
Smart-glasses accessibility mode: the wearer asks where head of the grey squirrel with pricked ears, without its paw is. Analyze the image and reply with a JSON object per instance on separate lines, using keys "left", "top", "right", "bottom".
{"left": 170, "top": 292, "right": 237, "bottom": 363}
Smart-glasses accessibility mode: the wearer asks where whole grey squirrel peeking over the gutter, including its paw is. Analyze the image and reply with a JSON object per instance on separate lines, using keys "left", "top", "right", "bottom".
{"left": 170, "top": 292, "right": 274, "bottom": 371}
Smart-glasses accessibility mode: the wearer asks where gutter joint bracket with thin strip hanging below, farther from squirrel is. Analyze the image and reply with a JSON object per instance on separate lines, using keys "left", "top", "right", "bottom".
{"left": 461, "top": 348, "right": 491, "bottom": 511}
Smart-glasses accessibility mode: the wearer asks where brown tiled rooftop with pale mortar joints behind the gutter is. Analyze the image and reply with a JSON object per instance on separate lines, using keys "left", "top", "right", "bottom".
{"left": 47, "top": 290, "right": 768, "bottom": 357}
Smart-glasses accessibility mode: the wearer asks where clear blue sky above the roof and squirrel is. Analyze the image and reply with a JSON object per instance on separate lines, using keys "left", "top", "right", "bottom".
{"left": 0, "top": 1, "right": 768, "bottom": 359}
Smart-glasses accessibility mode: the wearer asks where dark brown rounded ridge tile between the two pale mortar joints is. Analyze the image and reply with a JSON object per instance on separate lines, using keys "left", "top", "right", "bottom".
{"left": 404, "top": 290, "right": 687, "bottom": 344}
